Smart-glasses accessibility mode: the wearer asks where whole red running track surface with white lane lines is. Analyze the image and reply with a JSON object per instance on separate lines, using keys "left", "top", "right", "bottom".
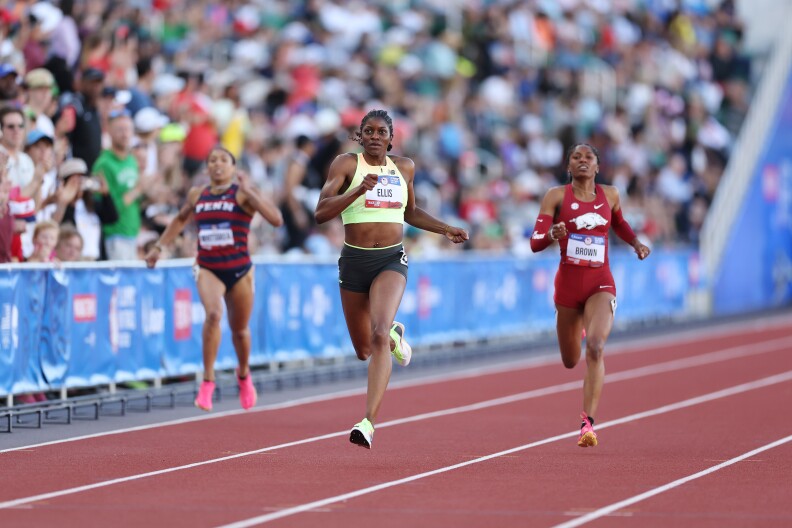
{"left": 0, "top": 318, "right": 792, "bottom": 528}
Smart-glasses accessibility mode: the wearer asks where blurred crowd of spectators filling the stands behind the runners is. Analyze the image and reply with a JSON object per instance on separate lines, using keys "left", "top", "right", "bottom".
{"left": 0, "top": 0, "right": 753, "bottom": 261}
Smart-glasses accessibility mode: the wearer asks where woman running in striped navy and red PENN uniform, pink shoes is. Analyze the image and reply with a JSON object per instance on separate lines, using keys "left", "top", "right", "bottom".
{"left": 146, "top": 147, "right": 283, "bottom": 411}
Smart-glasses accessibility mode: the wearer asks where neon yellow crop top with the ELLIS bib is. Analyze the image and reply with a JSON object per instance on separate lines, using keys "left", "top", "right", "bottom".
{"left": 341, "top": 154, "right": 407, "bottom": 225}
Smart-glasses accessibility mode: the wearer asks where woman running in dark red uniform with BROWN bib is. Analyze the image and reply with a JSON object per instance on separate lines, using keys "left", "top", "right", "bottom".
{"left": 531, "top": 144, "right": 650, "bottom": 447}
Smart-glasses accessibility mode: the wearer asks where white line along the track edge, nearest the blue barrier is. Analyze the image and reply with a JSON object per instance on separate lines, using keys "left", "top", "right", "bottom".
{"left": 0, "top": 315, "right": 792, "bottom": 454}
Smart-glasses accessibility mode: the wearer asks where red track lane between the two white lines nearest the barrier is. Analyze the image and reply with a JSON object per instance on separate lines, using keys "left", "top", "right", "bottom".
{"left": 0, "top": 330, "right": 789, "bottom": 501}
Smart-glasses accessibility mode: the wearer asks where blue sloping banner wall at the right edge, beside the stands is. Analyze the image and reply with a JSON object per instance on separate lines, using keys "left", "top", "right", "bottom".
{"left": 713, "top": 70, "right": 792, "bottom": 314}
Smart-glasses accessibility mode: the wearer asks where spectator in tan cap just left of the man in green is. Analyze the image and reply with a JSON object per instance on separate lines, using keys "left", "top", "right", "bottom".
{"left": 50, "top": 158, "right": 118, "bottom": 260}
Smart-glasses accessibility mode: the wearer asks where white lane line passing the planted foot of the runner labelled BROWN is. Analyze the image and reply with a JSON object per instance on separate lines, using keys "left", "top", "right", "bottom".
{"left": 213, "top": 370, "right": 792, "bottom": 528}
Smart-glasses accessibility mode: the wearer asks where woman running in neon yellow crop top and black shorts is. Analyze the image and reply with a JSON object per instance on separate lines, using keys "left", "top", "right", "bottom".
{"left": 315, "top": 110, "right": 468, "bottom": 449}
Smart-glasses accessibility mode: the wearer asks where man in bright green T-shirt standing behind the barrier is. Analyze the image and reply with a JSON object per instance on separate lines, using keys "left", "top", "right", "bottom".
{"left": 91, "top": 110, "right": 144, "bottom": 260}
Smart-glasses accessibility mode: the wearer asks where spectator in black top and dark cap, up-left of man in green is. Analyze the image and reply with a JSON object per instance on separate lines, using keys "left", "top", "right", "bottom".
{"left": 59, "top": 68, "right": 104, "bottom": 167}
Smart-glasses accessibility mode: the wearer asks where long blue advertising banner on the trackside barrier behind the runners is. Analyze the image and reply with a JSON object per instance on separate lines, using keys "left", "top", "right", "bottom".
{"left": 0, "top": 249, "right": 703, "bottom": 394}
